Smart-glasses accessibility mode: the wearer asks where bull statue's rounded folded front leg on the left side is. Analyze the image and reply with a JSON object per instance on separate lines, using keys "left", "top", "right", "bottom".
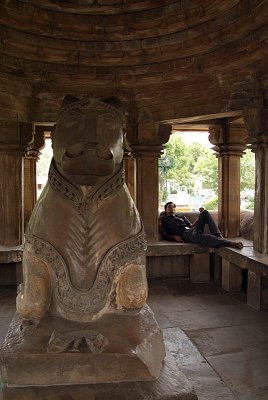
{"left": 17, "top": 251, "right": 51, "bottom": 322}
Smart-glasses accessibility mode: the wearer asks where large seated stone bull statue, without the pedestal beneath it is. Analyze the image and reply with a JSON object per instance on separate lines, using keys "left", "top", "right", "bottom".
{"left": 17, "top": 96, "right": 147, "bottom": 322}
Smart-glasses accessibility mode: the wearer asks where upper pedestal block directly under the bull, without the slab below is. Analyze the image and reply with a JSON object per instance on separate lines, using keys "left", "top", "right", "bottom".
{"left": 1, "top": 306, "right": 165, "bottom": 386}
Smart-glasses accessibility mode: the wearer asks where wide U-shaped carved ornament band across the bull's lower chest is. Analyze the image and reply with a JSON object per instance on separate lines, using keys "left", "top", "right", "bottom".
{"left": 25, "top": 227, "right": 146, "bottom": 317}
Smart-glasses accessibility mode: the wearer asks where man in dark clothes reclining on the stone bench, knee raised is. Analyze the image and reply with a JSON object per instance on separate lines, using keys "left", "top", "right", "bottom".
{"left": 160, "top": 201, "right": 243, "bottom": 249}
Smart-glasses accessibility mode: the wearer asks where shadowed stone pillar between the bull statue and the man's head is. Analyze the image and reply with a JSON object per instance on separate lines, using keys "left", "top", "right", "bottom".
{"left": 132, "top": 145, "right": 163, "bottom": 241}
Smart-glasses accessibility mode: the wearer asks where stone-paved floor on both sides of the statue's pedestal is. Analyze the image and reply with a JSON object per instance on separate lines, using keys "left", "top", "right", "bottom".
{"left": 0, "top": 278, "right": 268, "bottom": 400}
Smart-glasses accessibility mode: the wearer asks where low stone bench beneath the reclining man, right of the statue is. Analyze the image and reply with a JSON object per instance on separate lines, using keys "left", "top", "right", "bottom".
{"left": 146, "top": 237, "right": 268, "bottom": 310}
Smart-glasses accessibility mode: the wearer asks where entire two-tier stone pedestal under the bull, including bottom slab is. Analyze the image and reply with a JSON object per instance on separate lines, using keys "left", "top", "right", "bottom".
{"left": 1, "top": 306, "right": 197, "bottom": 400}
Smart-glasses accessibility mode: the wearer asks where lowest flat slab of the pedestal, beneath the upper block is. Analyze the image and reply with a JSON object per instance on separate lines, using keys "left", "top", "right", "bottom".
{"left": 2, "top": 354, "right": 197, "bottom": 400}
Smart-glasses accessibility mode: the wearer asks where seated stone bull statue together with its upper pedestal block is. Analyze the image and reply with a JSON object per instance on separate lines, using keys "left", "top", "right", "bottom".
{"left": 2, "top": 97, "right": 166, "bottom": 388}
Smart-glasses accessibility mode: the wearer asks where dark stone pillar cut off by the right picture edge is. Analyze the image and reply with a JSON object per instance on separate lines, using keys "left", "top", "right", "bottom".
{"left": 244, "top": 108, "right": 268, "bottom": 254}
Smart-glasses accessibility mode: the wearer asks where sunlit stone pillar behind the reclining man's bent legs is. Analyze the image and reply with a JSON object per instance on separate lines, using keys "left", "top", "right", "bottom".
{"left": 209, "top": 124, "right": 247, "bottom": 237}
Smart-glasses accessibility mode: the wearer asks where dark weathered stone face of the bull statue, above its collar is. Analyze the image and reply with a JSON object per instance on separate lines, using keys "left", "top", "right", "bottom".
{"left": 53, "top": 99, "right": 123, "bottom": 185}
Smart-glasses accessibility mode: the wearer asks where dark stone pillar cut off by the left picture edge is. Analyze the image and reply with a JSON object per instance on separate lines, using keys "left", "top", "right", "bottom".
{"left": 0, "top": 121, "right": 32, "bottom": 246}
